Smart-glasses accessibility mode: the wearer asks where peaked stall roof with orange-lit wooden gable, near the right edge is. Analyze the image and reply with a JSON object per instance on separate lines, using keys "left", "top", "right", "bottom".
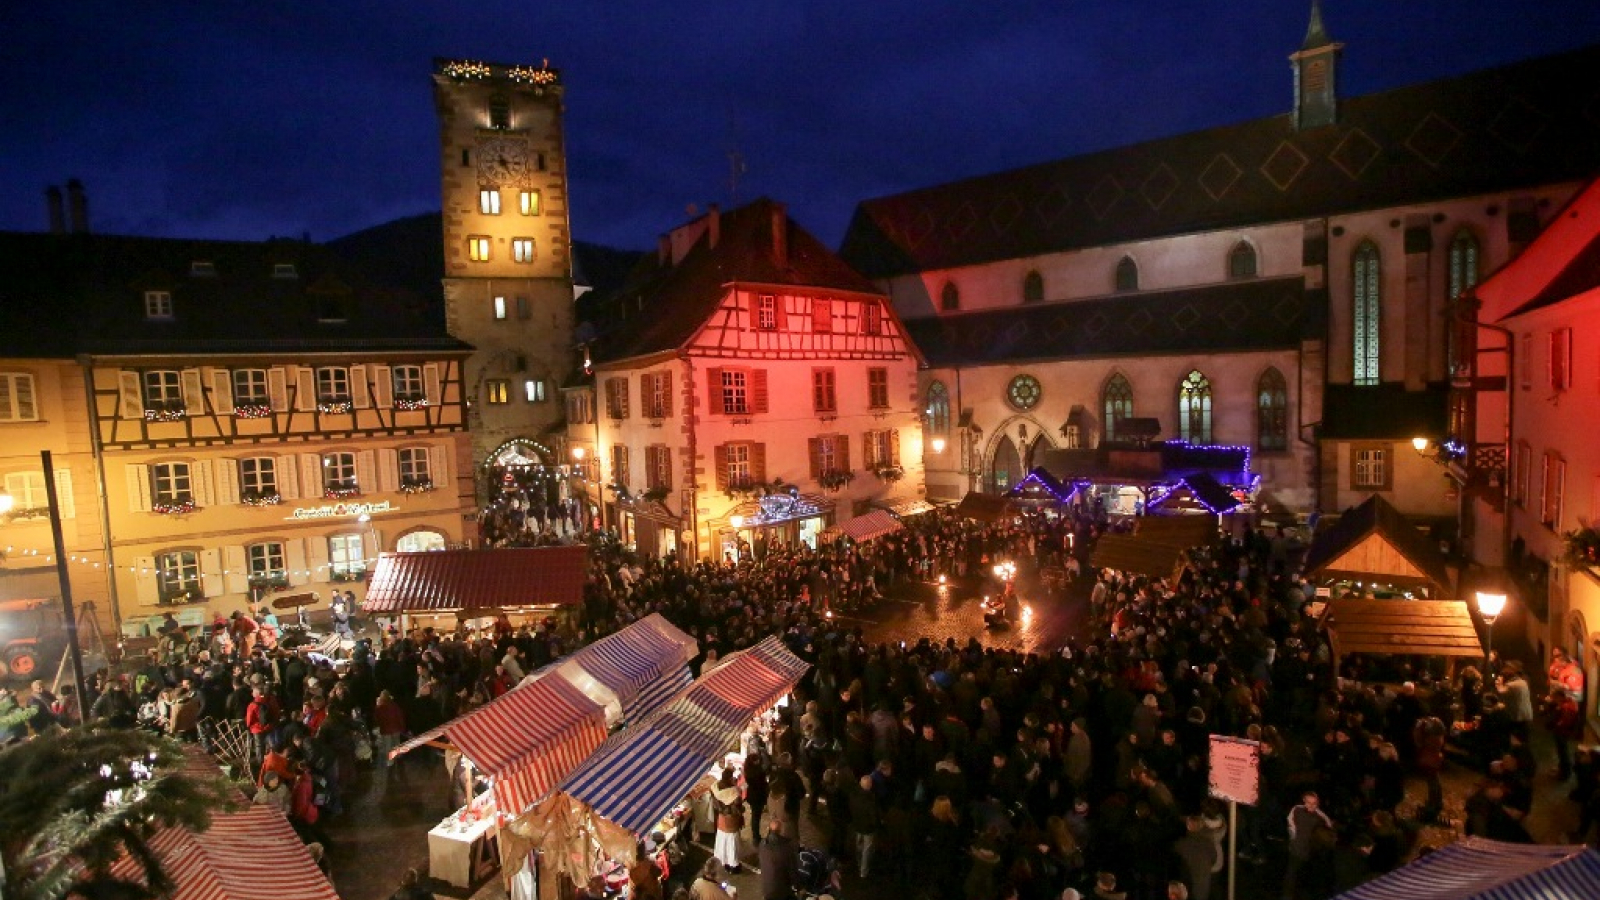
{"left": 1306, "top": 493, "right": 1454, "bottom": 597}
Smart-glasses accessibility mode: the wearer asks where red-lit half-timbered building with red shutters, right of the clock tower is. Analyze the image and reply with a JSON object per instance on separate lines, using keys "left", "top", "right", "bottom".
{"left": 566, "top": 200, "right": 923, "bottom": 557}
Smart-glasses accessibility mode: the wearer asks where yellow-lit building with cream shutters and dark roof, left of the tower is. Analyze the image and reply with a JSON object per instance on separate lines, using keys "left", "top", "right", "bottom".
{"left": 0, "top": 224, "right": 474, "bottom": 623}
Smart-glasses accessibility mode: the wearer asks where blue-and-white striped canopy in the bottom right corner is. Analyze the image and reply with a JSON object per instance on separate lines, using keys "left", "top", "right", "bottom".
{"left": 1334, "top": 838, "right": 1600, "bottom": 900}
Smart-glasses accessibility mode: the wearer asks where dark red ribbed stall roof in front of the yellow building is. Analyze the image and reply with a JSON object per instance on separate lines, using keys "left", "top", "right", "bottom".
{"left": 362, "top": 544, "right": 589, "bottom": 613}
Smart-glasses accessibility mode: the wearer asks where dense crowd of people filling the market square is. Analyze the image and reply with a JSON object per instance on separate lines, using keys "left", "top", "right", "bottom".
{"left": 6, "top": 496, "right": 1600, "bottom": 900}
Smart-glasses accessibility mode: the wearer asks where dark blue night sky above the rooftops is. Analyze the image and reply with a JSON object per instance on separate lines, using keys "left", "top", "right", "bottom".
{"left": 0, "top": 0, "right": 1600, "bottom": 247}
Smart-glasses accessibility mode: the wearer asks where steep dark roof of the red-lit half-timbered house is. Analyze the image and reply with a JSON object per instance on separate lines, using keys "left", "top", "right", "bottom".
{"left": 592, "top": 197, "right": 882, "bottom": 362}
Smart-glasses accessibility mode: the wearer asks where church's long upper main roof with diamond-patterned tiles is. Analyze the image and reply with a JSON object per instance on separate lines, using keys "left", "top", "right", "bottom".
{"left": 840, "top": 45, "right": 1600, "bottom": 277}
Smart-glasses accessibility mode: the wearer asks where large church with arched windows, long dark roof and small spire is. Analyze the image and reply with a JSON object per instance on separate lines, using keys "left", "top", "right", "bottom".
{"left": 840, "top": 3, "right": 1600, "bottom": 525}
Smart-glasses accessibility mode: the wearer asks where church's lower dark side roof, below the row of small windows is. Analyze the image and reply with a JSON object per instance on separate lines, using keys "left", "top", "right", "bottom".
{"left": 906, "top": 277, "right": 1323, "bottom": 365}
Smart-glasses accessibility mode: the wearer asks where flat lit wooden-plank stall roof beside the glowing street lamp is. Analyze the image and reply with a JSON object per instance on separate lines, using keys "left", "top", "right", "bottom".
{"left": 1322, "top": 601, "right": 1483, "bottom": 657}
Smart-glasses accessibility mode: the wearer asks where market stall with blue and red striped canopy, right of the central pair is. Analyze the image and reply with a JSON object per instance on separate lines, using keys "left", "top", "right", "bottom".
{"left": 501, "top": 637, "right": 808, "bottom": 897}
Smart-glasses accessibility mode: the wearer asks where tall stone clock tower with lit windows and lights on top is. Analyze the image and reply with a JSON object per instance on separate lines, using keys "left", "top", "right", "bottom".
{"left": 434, "top": 59, "right": 573, "bottom": 496}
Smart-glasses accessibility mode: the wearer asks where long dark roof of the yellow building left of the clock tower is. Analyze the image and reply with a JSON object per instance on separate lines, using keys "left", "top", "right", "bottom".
{"left": 0, "top": 232, "right": 470, "bottom": 357}
